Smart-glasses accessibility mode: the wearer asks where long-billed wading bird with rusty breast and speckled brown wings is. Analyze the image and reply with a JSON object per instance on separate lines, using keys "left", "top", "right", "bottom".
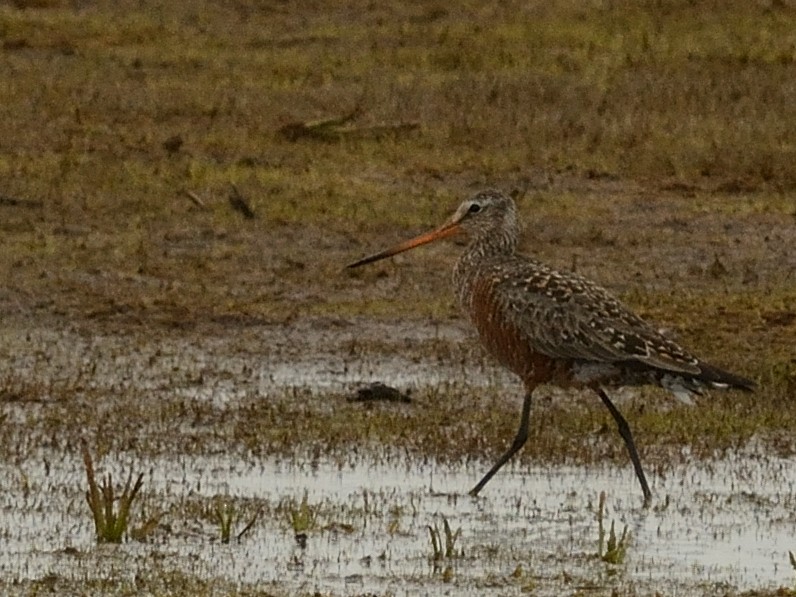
{"left": 346, "top": 189, "right": 755, "bottom": 506}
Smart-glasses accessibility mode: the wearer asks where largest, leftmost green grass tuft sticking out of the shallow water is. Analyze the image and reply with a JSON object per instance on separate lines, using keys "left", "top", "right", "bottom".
{"left": 81, "top": 440, "right": 144, "bottom": 543}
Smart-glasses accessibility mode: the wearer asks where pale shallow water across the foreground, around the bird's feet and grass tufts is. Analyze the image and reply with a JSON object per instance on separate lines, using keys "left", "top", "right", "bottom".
{"left": 0, "top": 451, "right": 796, "bottom": 594}
